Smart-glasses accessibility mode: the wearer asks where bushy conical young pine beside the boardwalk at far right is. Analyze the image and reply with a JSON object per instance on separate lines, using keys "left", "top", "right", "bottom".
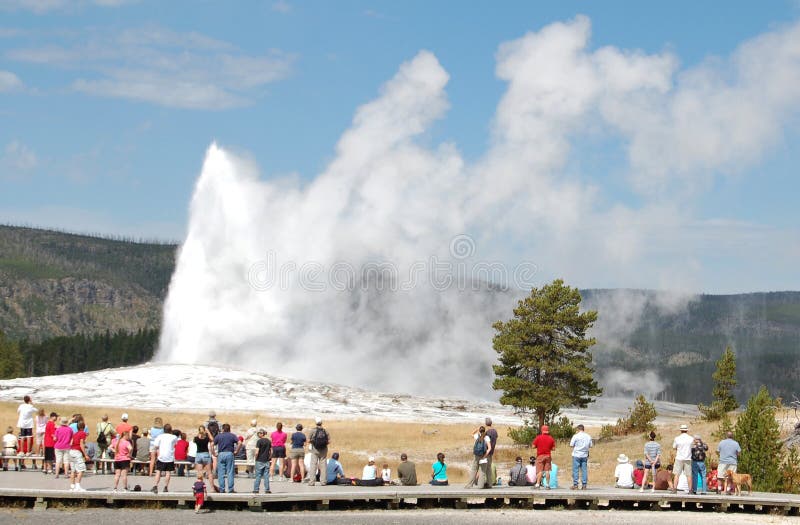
{"left": 734, "top": 386, "right": 783, "bottom": 492}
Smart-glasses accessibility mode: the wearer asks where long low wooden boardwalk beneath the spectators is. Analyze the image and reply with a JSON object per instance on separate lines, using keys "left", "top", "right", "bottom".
{"left": 0, "top": 471, "right": 800, "bottom": 515}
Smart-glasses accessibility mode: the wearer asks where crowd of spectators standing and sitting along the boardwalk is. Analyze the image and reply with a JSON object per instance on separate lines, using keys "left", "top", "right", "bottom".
{"left": 2, "top": 396, "right": 752, "bottom": 506}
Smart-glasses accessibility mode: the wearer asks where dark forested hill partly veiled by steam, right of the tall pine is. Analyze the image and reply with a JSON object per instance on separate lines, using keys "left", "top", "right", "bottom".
{"left": 582, "top": 290, "right": 800, "bottom": 403}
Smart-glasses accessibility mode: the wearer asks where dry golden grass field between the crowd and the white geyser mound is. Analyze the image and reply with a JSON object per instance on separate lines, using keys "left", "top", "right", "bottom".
{"left": 0, "top": 399, "right": 776, "bottom": 486}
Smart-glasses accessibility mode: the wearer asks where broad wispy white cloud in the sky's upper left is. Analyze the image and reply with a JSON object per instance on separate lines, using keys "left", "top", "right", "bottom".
{"left": 6, "top": 26, "right": 294, "bottom": 109}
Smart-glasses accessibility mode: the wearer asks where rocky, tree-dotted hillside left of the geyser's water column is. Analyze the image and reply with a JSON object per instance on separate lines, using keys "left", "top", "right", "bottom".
{"left": 0, "top": 226, "right": 176, "bottom": 341}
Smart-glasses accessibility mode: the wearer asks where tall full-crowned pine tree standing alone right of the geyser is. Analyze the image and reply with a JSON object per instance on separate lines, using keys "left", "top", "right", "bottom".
{"left": 492, "top": 279, "right": 602, "bottom": 426}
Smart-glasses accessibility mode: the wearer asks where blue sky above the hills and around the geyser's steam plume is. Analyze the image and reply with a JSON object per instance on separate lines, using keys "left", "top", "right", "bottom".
{"left": 0, "top": 0, "right": 800, "bottom": 291}
